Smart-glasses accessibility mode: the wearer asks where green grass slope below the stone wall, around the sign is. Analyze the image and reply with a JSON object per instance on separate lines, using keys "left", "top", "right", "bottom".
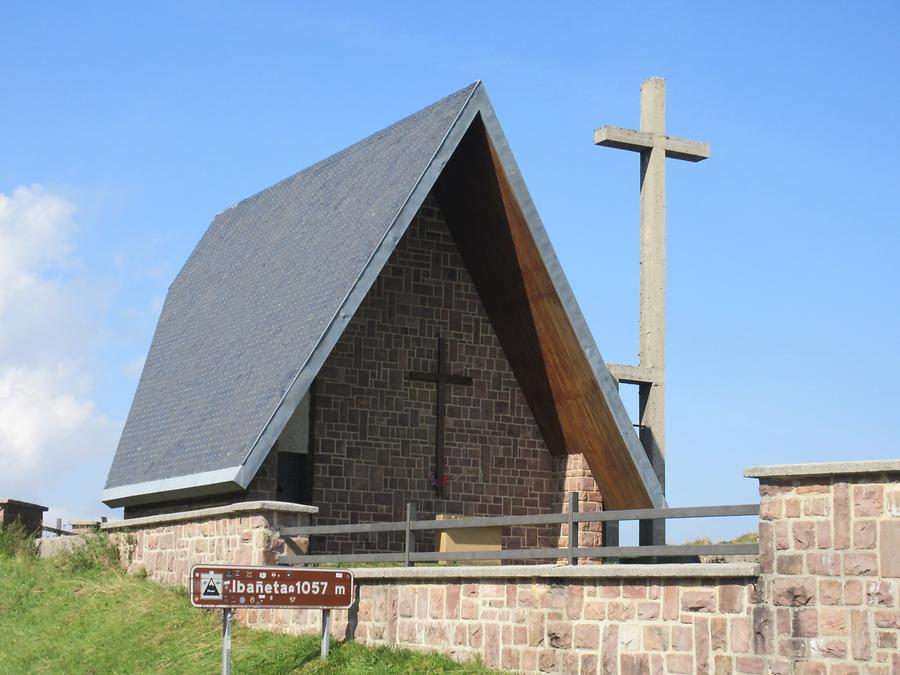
{"left": 0, "top": 528, "right": 500, "bottom": 675}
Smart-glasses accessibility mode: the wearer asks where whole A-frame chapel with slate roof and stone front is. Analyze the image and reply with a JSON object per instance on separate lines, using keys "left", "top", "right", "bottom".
{"left": 103, "top": 82, "right": 664, "bottom": 546}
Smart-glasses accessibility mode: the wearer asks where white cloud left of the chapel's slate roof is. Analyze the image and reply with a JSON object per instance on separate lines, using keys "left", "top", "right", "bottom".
{"left": 0, "top": 186, "right": 119, "bottom": 516}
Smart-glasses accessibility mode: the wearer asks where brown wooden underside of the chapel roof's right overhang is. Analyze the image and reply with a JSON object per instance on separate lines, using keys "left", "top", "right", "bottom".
{"left": 433, "top": 116, "right": 653, "bottom": 509}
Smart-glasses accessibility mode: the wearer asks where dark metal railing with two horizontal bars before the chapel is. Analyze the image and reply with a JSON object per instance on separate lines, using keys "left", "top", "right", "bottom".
{"left": 278, "top": 492, "right": 759, "bottom": 566}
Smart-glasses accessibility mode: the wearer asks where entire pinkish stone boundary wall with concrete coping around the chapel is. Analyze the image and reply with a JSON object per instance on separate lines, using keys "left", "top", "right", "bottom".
{"left": 59, "top": 460, "right": 900, "bottom": 675}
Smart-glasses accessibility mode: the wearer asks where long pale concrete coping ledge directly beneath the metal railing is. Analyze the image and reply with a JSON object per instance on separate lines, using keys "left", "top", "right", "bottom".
{"left": 351, "top": 563, "right": 759, "bottom": 581}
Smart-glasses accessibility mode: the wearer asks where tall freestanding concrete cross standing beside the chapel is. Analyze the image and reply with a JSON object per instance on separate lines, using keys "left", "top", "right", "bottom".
{"left": 594, "top": 77, "right": 709, "bottom": 544}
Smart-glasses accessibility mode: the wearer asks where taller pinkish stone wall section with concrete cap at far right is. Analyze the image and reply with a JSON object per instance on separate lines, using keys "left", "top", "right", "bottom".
{"left": 745, "top": 460, "right": 900, "bottom": 673}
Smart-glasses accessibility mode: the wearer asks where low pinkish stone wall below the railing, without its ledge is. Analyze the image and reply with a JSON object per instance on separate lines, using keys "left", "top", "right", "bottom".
{"left": 238, "top": 565, "right": 762, "bottom": 675}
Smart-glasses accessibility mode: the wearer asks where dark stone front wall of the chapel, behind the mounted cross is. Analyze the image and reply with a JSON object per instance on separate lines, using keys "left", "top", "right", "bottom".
{"left": 312, "top": 199, "right": 602, "bottom": 551}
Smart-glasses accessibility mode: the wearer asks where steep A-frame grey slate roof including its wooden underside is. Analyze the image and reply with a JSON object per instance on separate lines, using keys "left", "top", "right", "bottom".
{"left": 103, "top": 82, "right": 664, "bottom": 508}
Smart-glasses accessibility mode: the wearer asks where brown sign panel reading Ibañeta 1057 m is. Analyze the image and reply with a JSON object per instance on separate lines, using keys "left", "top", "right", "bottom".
{"left": 190, "top": 565, "right": 353, "bottom": 609}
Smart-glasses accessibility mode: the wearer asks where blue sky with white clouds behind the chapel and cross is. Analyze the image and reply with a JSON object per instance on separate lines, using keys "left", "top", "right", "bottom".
{"left": 0, "top": 2, "right": 900, "bottom": 539}
